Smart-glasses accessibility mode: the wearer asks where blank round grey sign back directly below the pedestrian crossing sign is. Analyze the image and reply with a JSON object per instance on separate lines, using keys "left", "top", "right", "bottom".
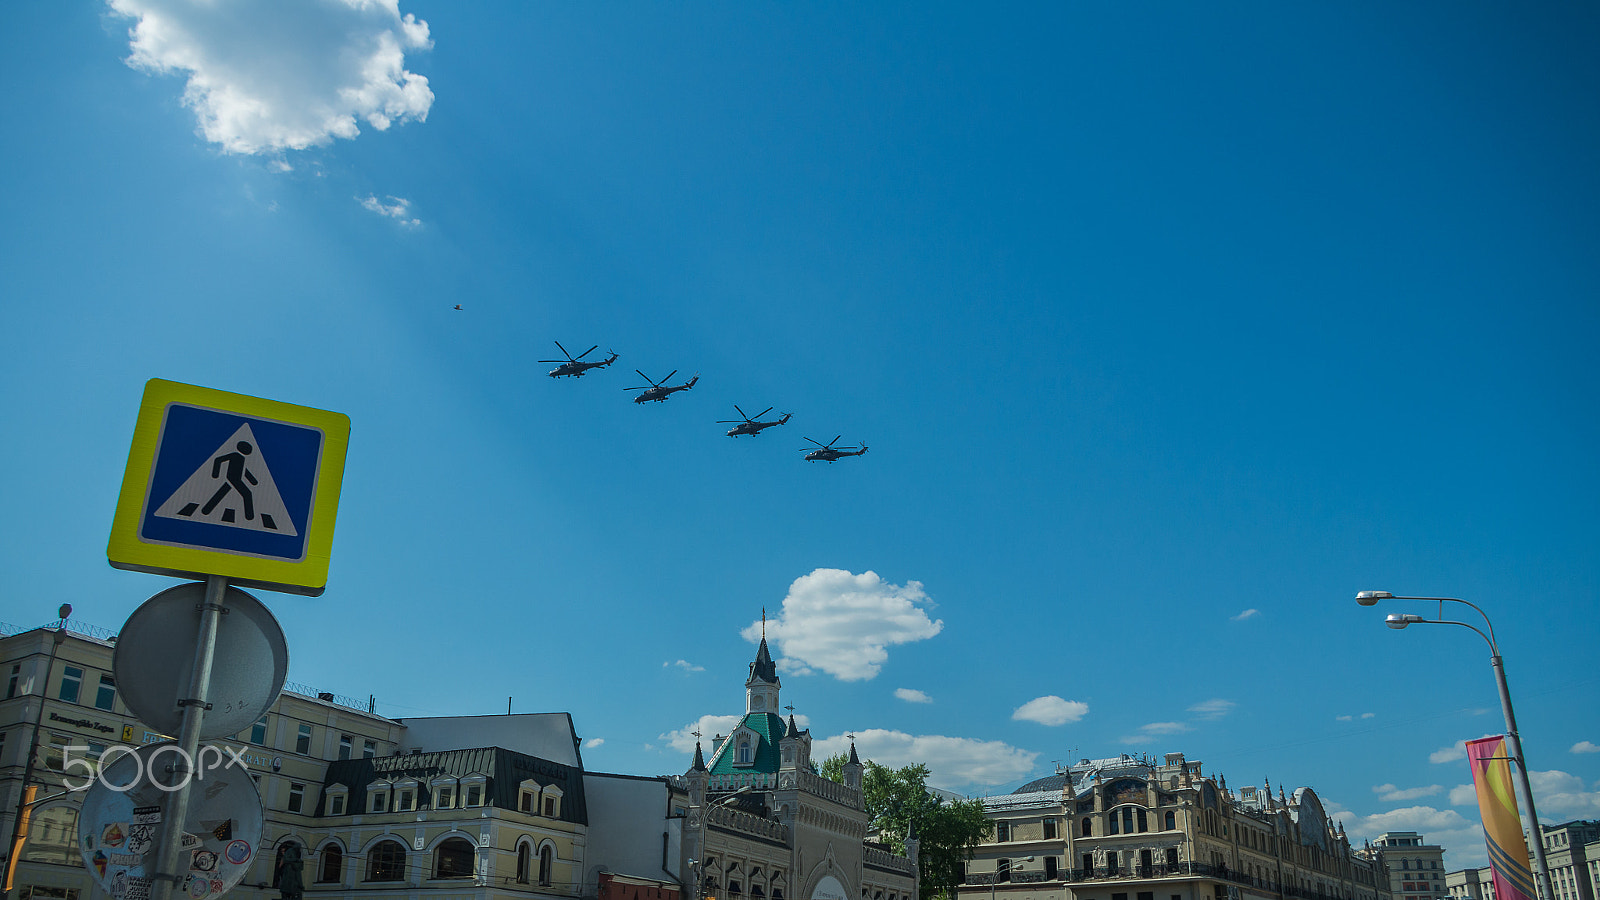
{"left": 112, "top": 583, "right": 290, "bottom": 740}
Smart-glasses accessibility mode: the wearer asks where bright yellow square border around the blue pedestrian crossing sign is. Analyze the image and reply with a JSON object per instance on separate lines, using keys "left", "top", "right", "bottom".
{"left": 106, "top": 378, "right": 350, "bottom": 597}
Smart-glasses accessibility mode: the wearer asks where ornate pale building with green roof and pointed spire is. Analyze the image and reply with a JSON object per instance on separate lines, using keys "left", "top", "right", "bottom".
{"left": 682, "top": 636, "right": 917, "bottom": 900}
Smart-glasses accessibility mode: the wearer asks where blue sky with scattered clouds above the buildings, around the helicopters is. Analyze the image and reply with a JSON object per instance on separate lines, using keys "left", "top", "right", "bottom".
{"left": 0, "top": 0, "right": 1600, "bottom": 868}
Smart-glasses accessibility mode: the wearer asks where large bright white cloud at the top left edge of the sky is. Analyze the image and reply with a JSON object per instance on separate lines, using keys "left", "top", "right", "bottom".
{"left": 109, "top": 0, "right": 434, "bottom": 154}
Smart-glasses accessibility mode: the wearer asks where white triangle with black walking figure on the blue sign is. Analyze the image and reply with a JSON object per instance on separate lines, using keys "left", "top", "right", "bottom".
{"left": 155, "top": 423, "right": 299, "bottom": 536}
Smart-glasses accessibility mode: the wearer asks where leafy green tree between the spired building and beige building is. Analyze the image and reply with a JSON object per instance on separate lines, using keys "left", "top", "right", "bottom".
{"left": 821, "top": 754, "right": 989, "bottom": 900}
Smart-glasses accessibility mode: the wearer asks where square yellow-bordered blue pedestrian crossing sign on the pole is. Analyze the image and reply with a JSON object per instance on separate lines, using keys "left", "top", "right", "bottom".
{"left": 106, "top": 378, "right": 350, "bottom": 597}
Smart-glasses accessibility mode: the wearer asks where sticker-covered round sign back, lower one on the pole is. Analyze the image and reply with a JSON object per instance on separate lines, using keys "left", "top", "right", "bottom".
{"left": 78, "top": 741, "right": 262, "bottom": 900}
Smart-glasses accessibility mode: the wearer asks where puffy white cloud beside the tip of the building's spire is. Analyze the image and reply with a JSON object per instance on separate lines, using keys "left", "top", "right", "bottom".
{"left": 741, "top": 569, "right": 944, "bottom": 681}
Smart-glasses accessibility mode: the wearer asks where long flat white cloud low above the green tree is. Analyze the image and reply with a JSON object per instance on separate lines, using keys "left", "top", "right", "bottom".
{"left": 811, "top": 729, "right": 1038, "bottom": 791}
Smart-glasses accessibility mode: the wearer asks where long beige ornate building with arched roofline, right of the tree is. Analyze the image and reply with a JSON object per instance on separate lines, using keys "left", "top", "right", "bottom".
{"left": 958, "top": 753, "right": 1392, "bottom": 900}
